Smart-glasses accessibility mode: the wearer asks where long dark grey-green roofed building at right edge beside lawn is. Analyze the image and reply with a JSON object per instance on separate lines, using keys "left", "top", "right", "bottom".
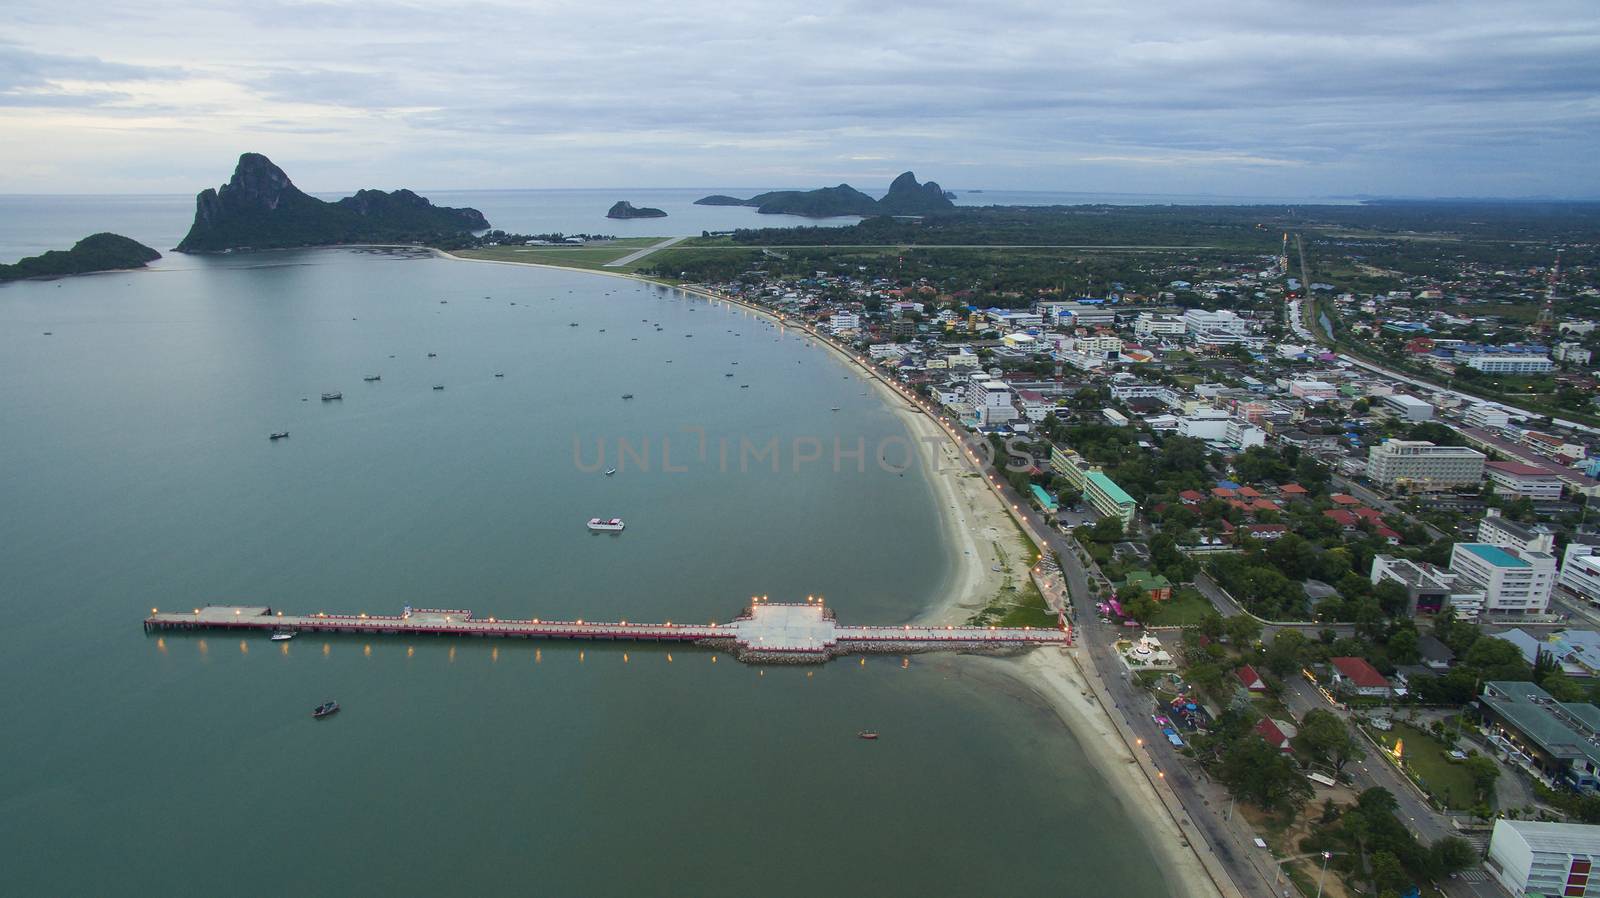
{"left": 1478, "top": 680, "right": 1600, "bottom": 790}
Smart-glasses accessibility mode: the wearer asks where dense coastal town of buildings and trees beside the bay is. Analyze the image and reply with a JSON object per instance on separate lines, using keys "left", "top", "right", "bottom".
{"left": 658, "top": 225, "right": 1600, "bottom": 896}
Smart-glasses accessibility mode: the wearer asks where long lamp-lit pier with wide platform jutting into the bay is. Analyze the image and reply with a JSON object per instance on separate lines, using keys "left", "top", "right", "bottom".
{"left": 144, "top": 599, "right": 1072, "bottom": 664}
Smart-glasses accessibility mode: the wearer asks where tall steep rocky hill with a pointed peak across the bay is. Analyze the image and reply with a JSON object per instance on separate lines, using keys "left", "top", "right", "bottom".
{"left": 178, "top": 152, "right": 490, "bottom": 253}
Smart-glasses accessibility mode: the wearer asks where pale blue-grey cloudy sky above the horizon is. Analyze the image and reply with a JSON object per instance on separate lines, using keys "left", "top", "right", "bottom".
{"left": 0, "top": 0, "right": 1600, "bottom": 198}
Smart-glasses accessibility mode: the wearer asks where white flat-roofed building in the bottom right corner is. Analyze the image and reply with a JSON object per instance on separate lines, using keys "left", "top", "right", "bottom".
{"left": 1485, "top": 820, "right": 1600, "bottom": 898}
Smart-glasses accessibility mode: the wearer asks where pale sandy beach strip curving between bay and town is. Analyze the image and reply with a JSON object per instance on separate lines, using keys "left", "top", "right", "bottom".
{"left": 434, "top": 243, "right": 1222, "bottom": 898}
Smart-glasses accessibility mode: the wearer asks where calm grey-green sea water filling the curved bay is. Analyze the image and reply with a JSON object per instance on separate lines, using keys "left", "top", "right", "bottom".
{"left": 0, "top": 190, "right": 1173, "bottom": 898}
